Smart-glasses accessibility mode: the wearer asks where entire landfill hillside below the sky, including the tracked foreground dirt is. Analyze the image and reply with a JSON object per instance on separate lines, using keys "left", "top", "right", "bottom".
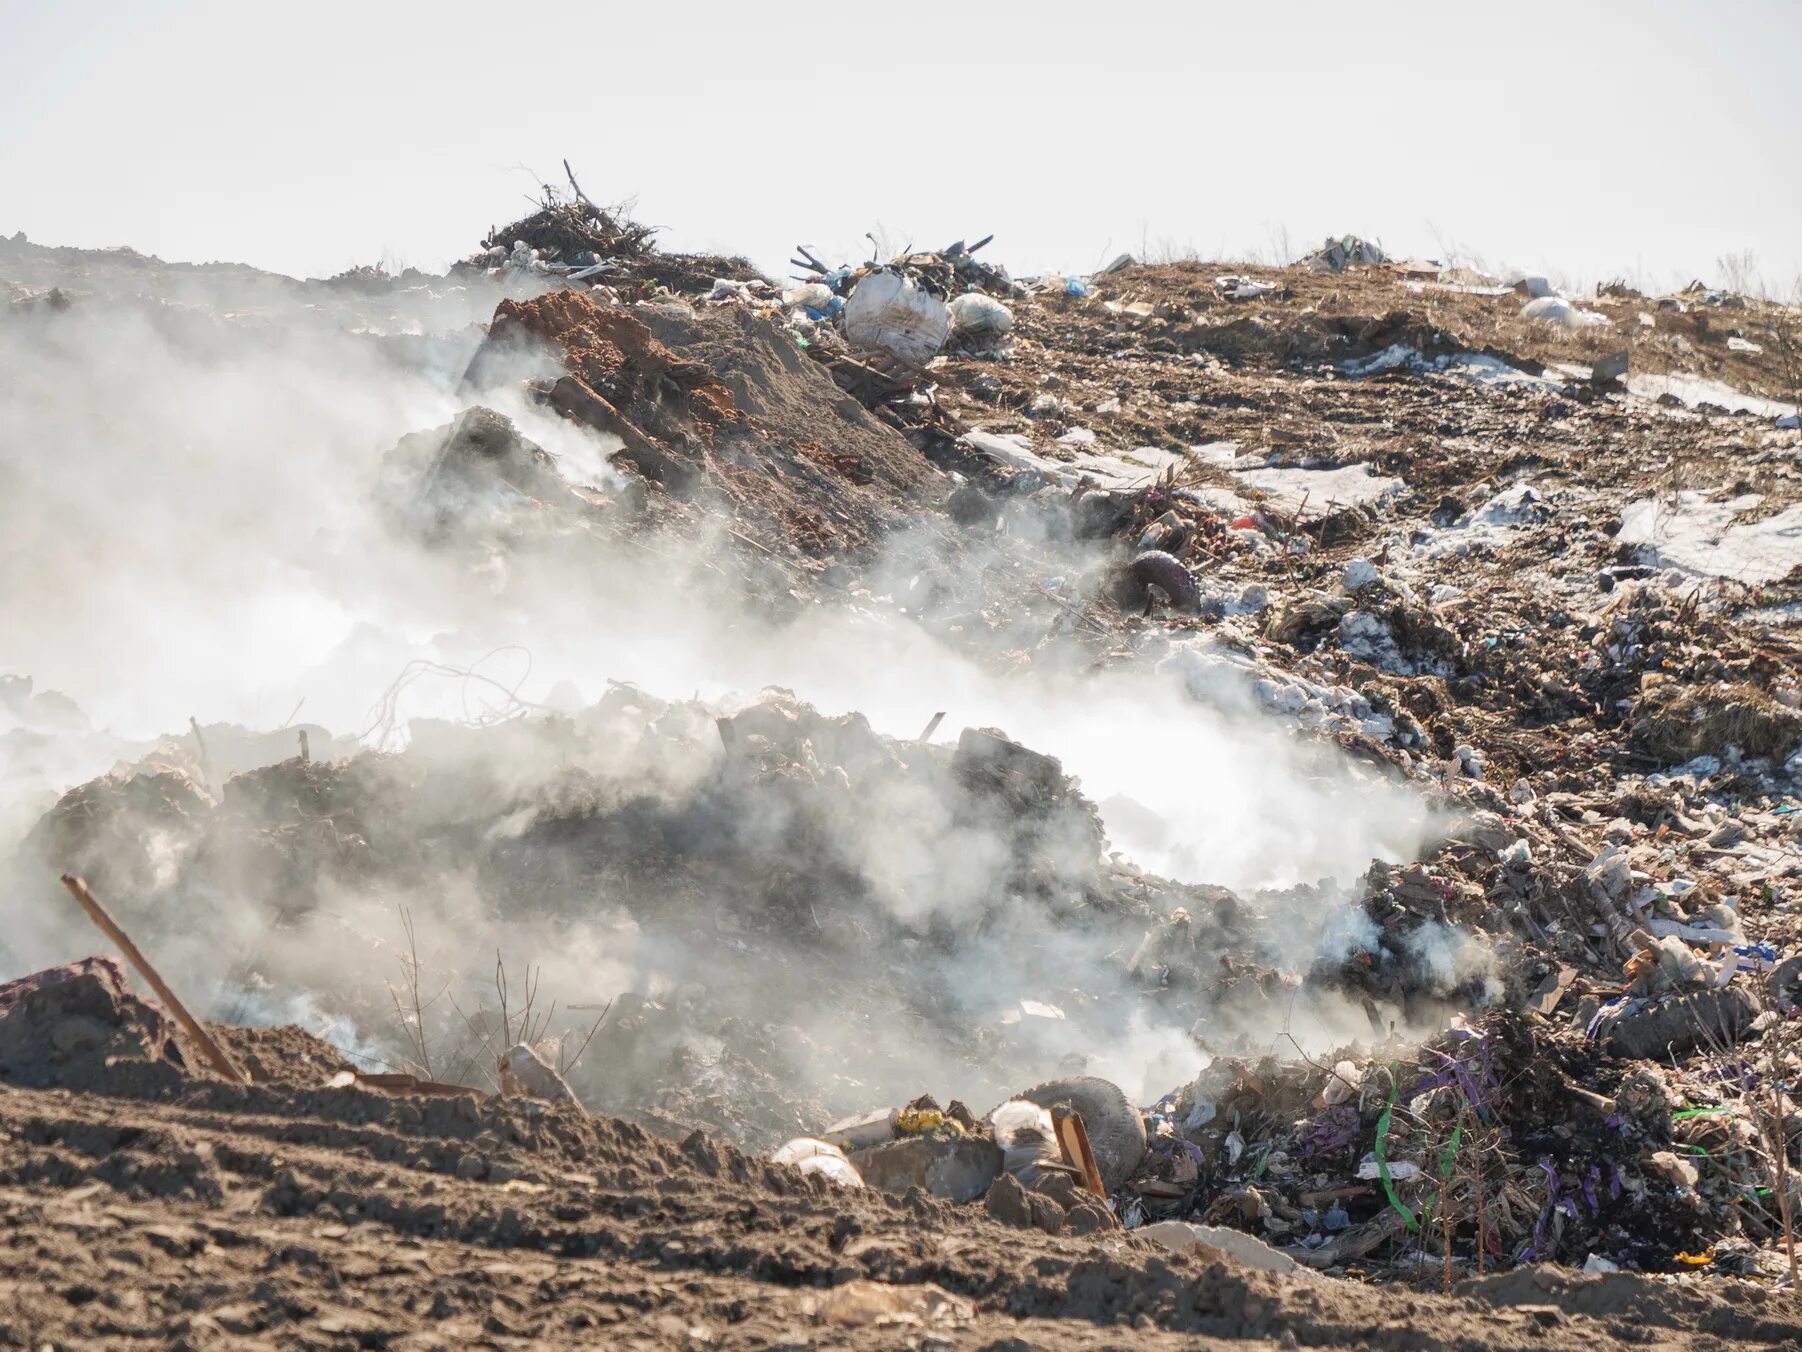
{"left": 0, "top": 192, "right": 1802, "bottom": 1347}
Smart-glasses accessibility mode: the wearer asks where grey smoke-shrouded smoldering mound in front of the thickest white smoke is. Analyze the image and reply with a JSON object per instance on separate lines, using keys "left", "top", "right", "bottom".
{"left": 9, "top": 685, "right": 1326, "bottom": 1143}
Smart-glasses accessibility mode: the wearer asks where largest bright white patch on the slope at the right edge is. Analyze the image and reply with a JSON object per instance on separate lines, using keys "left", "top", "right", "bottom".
{"left": 1615, "top": 492, "right": 1802, "bottom": 586}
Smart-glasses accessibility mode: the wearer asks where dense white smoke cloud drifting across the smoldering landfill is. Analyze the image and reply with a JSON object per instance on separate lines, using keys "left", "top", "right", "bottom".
{"left": 0, "top": 254, "right": 1441, "bottom": 1132}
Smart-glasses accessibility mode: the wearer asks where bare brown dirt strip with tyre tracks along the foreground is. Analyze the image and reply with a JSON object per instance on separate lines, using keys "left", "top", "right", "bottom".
{"left": 0, "top": 1045, "right": 1802, "bottom": 1350}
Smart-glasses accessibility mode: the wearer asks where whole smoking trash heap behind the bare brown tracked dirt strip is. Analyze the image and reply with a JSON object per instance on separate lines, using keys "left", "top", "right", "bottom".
{"left": 0, "top": 175, "right": 1802, "bottom": 1348}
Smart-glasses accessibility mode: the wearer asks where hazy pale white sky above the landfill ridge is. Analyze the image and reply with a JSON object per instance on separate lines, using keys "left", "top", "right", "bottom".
{"left": 0, "top": 0, "right": 1802, "bottom": 285}
